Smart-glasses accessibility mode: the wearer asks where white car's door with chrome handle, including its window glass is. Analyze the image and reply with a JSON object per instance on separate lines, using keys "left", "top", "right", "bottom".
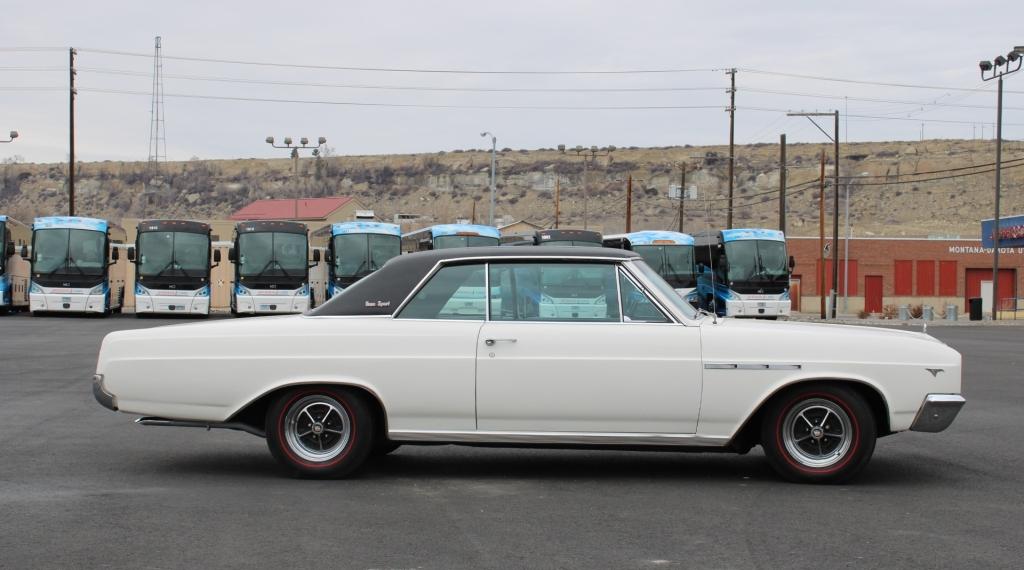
{"left": 476, "top": 261, "right": 701, "bottom": 435}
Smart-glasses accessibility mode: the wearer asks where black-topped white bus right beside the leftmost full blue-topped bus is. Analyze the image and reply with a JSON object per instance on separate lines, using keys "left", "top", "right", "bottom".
{"left": 128, "top": 220, "right": 220, "bottom": 316}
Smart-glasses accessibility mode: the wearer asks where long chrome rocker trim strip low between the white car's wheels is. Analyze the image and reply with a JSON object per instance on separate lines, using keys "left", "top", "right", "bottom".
{"left": 387, "top": 430, "right": 729, "bottom": 447}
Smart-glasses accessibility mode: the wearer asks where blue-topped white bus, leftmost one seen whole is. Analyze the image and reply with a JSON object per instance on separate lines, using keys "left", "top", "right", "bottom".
{"left": 26, "top": 216, "right": 126, "bottom": 314}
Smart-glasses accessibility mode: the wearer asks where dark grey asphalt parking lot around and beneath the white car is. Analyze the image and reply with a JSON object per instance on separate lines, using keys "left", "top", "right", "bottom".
{"left": 0, "top": 315, "right": 1024, "bottom": 569}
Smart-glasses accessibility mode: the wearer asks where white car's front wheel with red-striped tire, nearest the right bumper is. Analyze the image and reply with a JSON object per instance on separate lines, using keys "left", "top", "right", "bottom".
{"left": 761, "top": 384, "right": 877, "bottom": 483}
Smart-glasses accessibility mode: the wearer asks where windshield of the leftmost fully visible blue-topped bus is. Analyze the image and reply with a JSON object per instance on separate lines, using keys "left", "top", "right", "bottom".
{"left": 32, "top": 228, "right": 106, "bottom": 276}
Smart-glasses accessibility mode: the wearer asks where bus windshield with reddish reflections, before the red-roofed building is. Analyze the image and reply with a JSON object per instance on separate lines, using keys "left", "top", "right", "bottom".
{"left": 238, "top": 231, "right": 308, "bottom": 277}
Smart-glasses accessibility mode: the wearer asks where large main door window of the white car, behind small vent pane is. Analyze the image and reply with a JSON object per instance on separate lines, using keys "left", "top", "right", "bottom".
{"left": 490, "top": 263, "right": 620, "bottom": 322}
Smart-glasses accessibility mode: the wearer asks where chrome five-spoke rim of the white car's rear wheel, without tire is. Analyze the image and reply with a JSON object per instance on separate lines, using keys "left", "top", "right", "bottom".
{"left": 285, "top": 395, "right": 352, "bottom": 463}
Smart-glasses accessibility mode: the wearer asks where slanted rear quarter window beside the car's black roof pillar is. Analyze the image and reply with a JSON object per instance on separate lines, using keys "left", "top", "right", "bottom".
{"left": 397, "top": 264, "right": 487, "bottom": 320}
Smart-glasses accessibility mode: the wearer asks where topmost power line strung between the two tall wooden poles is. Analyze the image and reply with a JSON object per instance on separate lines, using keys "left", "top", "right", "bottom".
{"left": 78, "top": 48, "right": 719, "bottom": 75}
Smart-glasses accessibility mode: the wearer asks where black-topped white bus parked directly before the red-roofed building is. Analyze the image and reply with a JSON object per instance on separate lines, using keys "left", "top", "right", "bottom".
{"left": 227, "top": 221, "right": 321, "bottom": 315}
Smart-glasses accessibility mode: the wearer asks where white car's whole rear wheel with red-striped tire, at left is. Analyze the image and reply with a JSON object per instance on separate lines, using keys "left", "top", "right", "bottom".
{"left": 266, "top": 387, "right": 375, "bottom": 478}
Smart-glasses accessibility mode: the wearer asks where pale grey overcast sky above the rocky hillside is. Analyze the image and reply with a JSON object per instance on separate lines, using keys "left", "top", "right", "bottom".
{"left": 0, "top": 0, "right": 1024, "bottom": 162}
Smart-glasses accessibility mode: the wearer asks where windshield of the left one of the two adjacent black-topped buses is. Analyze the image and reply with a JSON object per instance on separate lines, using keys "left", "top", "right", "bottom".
{"left": 138, "top": 231, "right": 210, "bottom": 277}
